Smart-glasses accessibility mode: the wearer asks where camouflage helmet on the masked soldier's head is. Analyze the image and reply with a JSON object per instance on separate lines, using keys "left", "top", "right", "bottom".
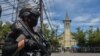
{"left": 19, "top": 5, "right": 40, "bottom": 18}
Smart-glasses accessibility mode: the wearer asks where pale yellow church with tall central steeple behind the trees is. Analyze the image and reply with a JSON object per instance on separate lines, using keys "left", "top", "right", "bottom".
{"left": 59, "top": 15, "right": 77, "bottom": 49}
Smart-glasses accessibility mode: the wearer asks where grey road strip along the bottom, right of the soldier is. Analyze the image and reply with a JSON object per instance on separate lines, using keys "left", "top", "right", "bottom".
{"left": 52, "top": 53, "right": 100, "bottom": 56}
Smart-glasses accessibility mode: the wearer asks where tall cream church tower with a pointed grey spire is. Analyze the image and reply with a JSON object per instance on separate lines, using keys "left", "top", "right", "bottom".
{"left": 64, "top": 13, "right": 72, "bottom": 48}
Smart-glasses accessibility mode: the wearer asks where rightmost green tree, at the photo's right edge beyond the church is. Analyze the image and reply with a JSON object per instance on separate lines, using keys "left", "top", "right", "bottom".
{"left": 88, "top": 28, "right": 100, "bottom": 46}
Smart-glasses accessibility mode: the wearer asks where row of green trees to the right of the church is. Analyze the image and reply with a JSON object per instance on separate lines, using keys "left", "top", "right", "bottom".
{"left": 73, "top": 28, "right": 100, "bottom": 47}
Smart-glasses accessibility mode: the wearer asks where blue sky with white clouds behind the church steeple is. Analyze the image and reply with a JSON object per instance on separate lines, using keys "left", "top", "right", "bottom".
{"left": 2, "top": 0, "right": 100, "bottom": 34}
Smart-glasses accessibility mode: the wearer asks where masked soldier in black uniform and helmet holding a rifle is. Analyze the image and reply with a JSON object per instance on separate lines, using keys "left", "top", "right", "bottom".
{"left": 2, "top": 5, "right": 39, "bottom": 56}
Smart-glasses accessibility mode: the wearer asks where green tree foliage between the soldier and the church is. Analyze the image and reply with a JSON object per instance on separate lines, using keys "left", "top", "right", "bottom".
{"left": 44, "top": 24, "right": 60, "bottom": 48}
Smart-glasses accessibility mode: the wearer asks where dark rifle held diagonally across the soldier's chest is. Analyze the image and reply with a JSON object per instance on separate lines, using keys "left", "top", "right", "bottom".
{"left": 13, "top": 19, "right": 50, "bottom": 56}
